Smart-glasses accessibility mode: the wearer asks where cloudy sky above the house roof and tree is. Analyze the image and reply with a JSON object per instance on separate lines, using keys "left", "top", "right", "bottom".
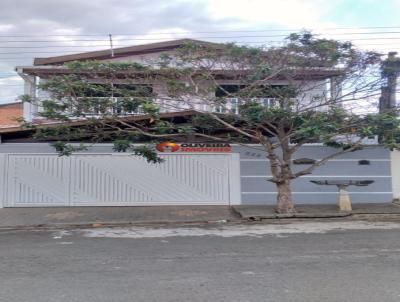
{"left": 0, "top": 0, "right": 400, "bottom": 103}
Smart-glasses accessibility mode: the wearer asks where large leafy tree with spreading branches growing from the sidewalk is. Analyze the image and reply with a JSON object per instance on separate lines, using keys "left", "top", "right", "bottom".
{"left": 22, "top": 32, "right": 400, "bottom": 213}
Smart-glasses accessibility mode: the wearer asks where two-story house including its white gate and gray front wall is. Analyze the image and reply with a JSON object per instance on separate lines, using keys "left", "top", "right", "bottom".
{"left": 0, "top": 39, "right": 393, "bottom": 207}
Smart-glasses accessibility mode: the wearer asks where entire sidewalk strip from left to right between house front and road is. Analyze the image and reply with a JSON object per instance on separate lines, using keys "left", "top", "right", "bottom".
{"left": 0, "top": 203, "right": 400, "bottom": 229}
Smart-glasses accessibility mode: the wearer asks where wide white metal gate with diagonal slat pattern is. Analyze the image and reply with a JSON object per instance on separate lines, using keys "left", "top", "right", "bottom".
{"left": 0, "top": 153, "right": 240, "bottom": 207}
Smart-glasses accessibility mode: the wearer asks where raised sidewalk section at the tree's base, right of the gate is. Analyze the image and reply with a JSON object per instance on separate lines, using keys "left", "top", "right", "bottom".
{"left": 233, "top": 203, "right": 400, "bottom": 220}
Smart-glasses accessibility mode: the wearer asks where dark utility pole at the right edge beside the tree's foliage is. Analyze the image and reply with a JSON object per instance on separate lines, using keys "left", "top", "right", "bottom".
{"left": 379, "top": 51, "right": 400, "bottom": 112}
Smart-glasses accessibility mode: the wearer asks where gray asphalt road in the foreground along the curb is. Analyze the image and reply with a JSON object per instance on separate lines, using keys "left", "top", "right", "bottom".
{"left": 0, "top": 222, "right": 400, "bottom": 302}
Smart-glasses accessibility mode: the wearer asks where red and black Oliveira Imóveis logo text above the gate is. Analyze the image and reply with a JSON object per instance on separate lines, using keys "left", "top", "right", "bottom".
{"left": 156, "top": 142, "right": 232, "bottom": 152}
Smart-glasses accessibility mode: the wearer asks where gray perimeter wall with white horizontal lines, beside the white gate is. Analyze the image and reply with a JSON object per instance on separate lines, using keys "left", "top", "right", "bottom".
{"left": 0, "top": 143, "right": 393, "bottom": 204}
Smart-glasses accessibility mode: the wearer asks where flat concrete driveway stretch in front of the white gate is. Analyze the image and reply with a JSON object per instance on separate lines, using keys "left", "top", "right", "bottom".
{"left": 0, "top": 206, "right": 240, "bottom": 228}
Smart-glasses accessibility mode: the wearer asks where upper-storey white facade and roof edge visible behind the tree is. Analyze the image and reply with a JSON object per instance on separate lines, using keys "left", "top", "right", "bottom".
{"left": 16, "top": 40, "right": 341, "bottom": 123}
